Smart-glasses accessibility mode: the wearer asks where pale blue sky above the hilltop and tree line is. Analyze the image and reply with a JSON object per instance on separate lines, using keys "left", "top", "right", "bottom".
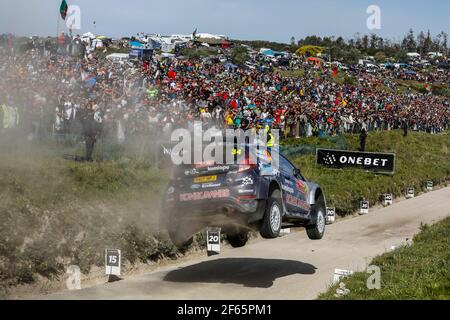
{"left": 0, "top": 0, "right": 450, "bottom": 42}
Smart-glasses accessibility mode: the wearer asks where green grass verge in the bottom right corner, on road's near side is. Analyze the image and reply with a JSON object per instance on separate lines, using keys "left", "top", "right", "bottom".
{"left": 319, "top": 218, "right": 450, "bottom": 300}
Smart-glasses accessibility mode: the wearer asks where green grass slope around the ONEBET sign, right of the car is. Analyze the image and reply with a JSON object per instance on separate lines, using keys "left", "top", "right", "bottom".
{"left": 291, "top": 131, "right": 450, "bottom": 215}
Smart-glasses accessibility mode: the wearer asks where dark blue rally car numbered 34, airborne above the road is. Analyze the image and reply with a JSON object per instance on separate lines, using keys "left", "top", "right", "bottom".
{"left": 161, "top": 146, "right": 326, "bottom": 249}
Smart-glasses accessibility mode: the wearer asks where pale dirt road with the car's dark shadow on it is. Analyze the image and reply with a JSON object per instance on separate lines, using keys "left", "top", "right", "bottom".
{"left": 37, "top": 187, "right": 450, "bottom": 299}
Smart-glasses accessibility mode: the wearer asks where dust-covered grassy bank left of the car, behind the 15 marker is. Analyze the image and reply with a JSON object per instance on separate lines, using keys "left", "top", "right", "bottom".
{"left": 0, "top": 146, "right": 174, "bottom": 290}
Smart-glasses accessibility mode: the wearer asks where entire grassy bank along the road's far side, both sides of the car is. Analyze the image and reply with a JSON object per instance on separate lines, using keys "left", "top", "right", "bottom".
{"left": 0, "top": 132, "right": 450, "bottom": 296}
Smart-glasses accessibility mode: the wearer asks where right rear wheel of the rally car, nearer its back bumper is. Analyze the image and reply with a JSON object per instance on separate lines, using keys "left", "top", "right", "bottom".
{"left": 260, "top": 190, "right": 283, "bottom": 239}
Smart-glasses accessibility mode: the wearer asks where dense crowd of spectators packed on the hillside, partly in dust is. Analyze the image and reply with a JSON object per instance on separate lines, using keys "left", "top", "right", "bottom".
{"left": 0, "top": 35, "right": 450, "bottom": 145}
